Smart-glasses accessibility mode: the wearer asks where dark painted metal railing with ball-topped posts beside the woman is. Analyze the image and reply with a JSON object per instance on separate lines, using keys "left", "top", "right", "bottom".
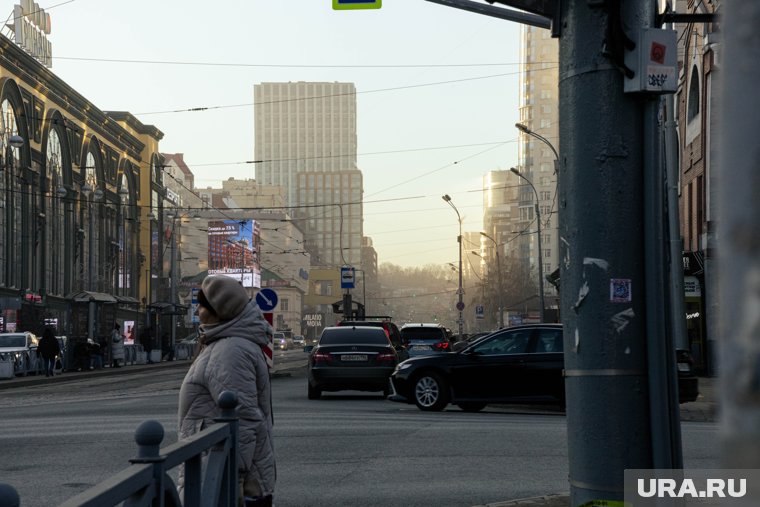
{"left": 0, "top": 391, "right": 238, "bottom": 507}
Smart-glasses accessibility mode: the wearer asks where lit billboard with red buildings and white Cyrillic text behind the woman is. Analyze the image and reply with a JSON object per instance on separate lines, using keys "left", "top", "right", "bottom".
{"left": 208, "top": 220, "right": 261, "bottom": 288}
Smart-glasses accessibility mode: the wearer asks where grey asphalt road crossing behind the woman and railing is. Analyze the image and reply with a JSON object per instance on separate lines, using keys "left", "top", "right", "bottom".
{"left": 0, "top": 358, "right": 718, "bottom": 507}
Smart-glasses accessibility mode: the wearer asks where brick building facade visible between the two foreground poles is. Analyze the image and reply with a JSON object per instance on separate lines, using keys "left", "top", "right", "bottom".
{"left": 676, "top": 0, "right": 720, "bottom": 373}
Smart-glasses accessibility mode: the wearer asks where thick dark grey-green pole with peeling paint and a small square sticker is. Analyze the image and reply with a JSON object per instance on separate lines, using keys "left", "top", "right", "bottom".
{"left": 558, "top": 0, "right": 656, "bottom": 506}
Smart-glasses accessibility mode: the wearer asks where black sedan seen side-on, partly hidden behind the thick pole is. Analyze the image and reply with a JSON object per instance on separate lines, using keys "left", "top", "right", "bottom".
{"left": 389, "top": 324, "right": 698, "bottom": 411}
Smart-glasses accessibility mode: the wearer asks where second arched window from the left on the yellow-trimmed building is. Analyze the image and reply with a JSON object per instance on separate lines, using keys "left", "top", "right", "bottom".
{"left": 45, "top": 128, "right": 70, "bottom": 295}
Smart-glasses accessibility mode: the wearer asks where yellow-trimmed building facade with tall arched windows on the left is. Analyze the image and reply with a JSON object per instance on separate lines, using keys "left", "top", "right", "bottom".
{"left": 0, "top": 31, "right": 163, "bottom": 339}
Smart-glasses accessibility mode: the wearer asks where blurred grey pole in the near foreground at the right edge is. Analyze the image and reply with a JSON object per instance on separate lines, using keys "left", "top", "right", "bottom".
{"left": 718, "top": 2, "right": 760, "bottom": 468}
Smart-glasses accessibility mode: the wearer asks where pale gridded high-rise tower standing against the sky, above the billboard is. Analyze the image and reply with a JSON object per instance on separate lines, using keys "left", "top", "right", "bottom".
{"left": 254, "top": 81, "right": 363, "bottom": 267}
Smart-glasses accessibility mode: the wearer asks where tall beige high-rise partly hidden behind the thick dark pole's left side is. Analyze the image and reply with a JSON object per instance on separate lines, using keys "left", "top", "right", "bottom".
{"left": 509, "top": 26, "right": 560, "bottom": 318}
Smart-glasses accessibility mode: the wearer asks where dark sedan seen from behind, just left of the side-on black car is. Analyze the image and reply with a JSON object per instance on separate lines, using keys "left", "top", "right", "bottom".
{"left": 305, "top": 326, "right": 406, "bottom": 400}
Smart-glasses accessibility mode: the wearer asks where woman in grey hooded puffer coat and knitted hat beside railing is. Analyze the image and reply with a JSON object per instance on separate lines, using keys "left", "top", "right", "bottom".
{"left": 178, "top": 275, "right": 276, "bottom": 507}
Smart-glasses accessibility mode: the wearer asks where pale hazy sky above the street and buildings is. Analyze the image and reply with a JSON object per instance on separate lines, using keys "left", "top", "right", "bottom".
{"left": 38, "top": 0, "right": 521, "bottom": 267}
